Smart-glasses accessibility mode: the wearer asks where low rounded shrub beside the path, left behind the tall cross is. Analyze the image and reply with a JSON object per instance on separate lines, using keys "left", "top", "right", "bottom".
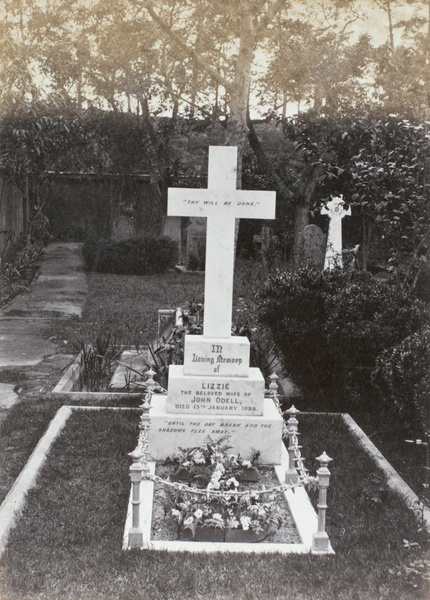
{"left": 83, "top": 236, "right": 178, "bottom": 275}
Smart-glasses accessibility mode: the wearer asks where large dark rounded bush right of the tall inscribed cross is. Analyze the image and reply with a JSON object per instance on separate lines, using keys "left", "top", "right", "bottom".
{"left": 259, "top": 268, "right": 428, "bottom": 409}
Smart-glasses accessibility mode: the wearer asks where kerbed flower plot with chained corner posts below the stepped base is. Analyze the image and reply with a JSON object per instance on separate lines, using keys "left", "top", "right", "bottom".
{"left": 123, "top": 392, "right": 334, "bottom": 554}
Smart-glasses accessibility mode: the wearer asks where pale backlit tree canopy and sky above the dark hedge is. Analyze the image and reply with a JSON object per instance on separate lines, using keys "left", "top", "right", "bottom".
{"left": 0, "top": 0, "right": 430, "bottom": 121}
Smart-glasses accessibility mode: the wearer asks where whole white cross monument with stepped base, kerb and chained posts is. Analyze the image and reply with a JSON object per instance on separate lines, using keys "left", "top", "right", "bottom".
{"left": 124, "top": 147, "right": 332, "bottom": 553}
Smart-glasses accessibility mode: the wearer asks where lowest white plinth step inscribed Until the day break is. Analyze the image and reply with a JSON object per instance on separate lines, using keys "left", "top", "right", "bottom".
{"left": 148, "top": 394, "right": 283, "bottom": 465}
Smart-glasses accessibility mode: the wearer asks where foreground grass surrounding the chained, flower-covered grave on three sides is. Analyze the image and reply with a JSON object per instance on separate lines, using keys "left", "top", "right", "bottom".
{"left": 1, "top": 411, "right": 428, "bottom": 600}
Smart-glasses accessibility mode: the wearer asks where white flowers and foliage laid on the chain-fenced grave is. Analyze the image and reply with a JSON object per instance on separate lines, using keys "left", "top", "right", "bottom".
{"left": 161, "top": 438, "right": 282, "bottom": 541}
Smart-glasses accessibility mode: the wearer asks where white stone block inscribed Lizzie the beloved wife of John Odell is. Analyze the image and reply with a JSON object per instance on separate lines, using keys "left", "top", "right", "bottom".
{"left": 167, "top": 365, "right": 264, "bottom": 415}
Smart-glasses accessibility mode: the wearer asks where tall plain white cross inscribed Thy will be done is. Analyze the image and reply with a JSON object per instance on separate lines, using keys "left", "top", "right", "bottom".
{"left": 167, "top": 146, "right": 276, "bottom": 338}
